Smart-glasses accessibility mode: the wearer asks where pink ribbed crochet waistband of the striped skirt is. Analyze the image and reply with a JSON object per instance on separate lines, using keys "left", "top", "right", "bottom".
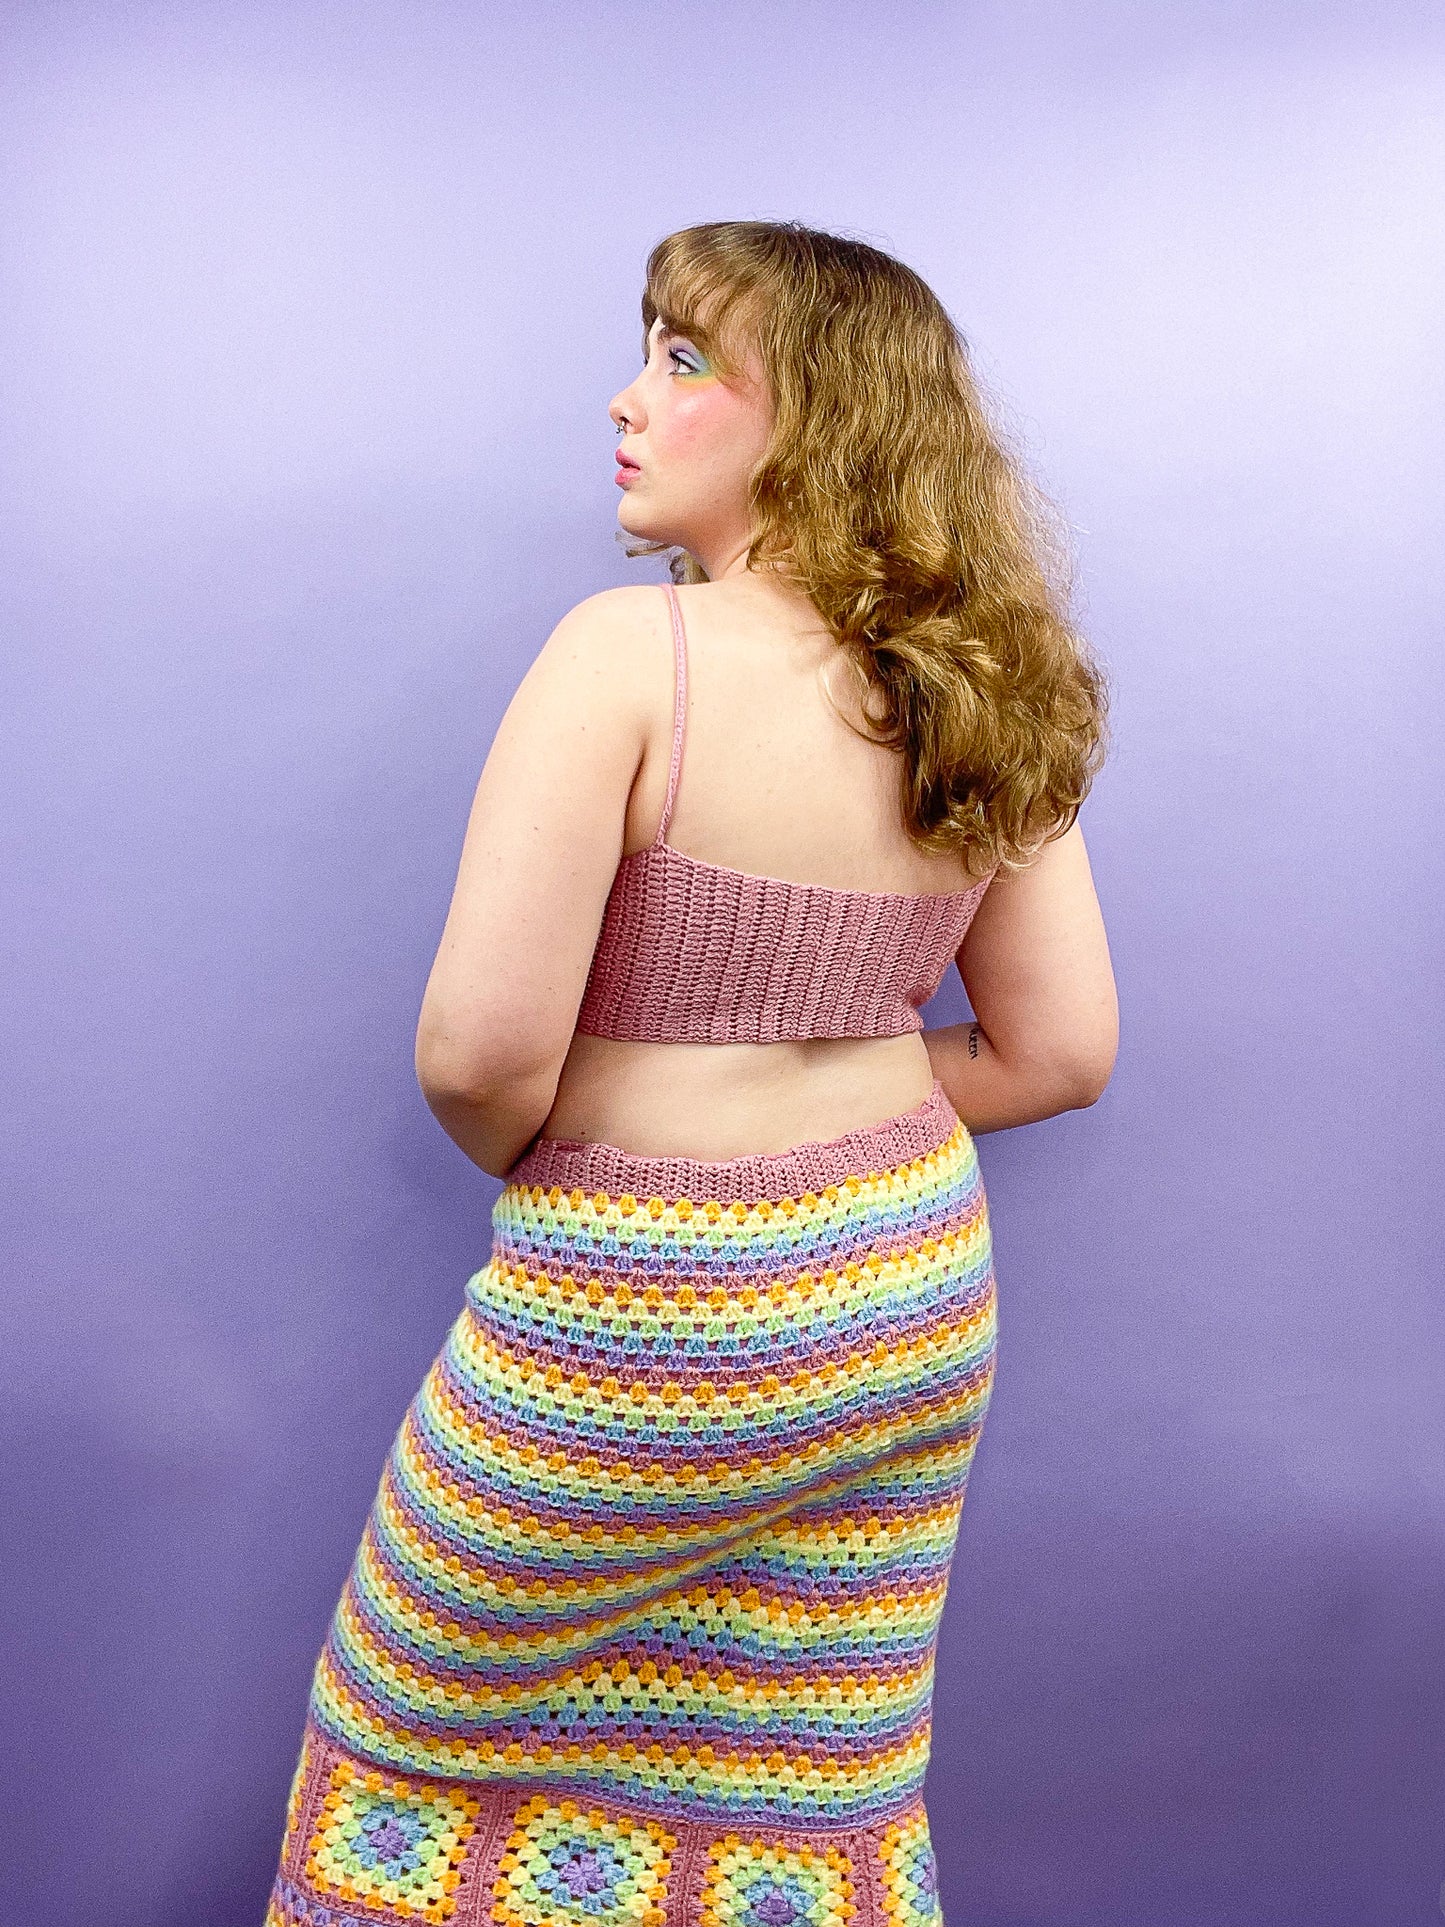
{"left": 507, "top": 1077, "right": 958, "bottom": 1204}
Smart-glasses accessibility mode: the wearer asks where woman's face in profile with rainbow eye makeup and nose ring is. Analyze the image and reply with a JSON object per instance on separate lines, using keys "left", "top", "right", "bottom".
{"left": 607, "top": 318, "right": 773, "bottom": 574}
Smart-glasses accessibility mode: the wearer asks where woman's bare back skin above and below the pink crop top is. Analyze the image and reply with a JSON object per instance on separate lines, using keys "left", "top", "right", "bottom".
{"left": 541, "top": 576, "right": 977, "bottom": 1158}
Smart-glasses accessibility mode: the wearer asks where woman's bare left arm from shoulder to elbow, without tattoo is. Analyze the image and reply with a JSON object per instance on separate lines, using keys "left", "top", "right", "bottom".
{"left": 416, "top": 588, "right": 670, "bottom": 1177}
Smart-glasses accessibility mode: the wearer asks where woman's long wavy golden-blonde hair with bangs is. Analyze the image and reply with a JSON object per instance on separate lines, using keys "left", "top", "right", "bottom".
{"left": 628, "top": 222, "right": 1106, "bottom": 875}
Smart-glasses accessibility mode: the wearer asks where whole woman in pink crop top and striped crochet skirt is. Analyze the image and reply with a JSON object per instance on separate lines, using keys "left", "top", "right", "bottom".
{"left": 268, "top": 222, "right": 1116, "bottom": 1927}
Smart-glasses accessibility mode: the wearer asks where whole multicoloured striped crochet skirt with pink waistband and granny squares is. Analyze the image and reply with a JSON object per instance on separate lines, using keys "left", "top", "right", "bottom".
{"left": 266, "top": 1083, "right": 996, "bottom": 1927}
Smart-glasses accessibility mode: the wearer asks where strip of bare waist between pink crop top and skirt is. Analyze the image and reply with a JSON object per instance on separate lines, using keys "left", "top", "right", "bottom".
{"left": 528, "top": 1031, "right": 934, "bottom": 1164}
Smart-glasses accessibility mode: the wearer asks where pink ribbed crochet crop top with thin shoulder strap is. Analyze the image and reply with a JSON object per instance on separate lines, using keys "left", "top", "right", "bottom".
{"left": 576, "top": 584, "right": 990, "bottom": 1044}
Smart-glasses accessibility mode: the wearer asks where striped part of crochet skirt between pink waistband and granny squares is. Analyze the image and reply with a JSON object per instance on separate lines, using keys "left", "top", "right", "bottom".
{"left": 300, "top": 1125, "right": 996, "bottom": 1826}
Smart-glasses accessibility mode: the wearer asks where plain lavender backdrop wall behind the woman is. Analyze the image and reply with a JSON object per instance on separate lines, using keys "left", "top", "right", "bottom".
{"left": 0, "top": 0, "right": 1445, "bottom": 1927}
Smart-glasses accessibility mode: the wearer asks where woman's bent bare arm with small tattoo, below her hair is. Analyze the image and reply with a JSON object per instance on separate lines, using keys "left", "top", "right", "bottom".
{"left": 923, "top": 823, "right": 1119, "bottom": 1135}
